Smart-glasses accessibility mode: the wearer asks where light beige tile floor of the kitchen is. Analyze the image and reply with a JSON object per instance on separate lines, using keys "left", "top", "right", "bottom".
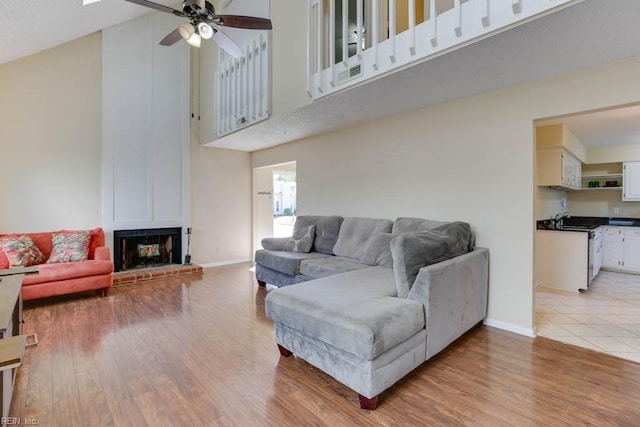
{"left": 536, "top": 271, "right": 640, "bottom": 363}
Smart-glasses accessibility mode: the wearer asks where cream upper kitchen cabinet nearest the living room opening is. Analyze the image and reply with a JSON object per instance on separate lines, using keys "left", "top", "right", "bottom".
{"left": 537, "top": 148, "right": 582, "bottom": 190}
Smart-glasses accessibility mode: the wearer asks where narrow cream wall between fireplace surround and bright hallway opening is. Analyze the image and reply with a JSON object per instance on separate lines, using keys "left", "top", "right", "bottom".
{"left": 191, "top": 26, "right": 253, "bottom": 267}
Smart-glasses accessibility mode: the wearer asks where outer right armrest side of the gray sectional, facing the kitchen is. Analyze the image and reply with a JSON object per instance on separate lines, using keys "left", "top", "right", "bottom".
{"left": 407, "top": 248, "right": 489, "bottom": 360}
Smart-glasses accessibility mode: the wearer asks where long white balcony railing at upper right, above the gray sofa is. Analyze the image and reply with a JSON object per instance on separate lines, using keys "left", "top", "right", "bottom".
{"left": 308, "top": 0, "right": 582, "bottom": 99}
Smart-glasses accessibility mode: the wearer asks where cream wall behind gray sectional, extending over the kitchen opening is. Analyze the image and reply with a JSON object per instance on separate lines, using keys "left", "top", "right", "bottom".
{"left": 252, "top": 59, "right": 640, "bottom": 333}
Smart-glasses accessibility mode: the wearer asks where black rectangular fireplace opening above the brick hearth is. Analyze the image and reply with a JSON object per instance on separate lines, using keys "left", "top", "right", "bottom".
{"left": 113, "top": 227, "right": 182, "bottom": 271}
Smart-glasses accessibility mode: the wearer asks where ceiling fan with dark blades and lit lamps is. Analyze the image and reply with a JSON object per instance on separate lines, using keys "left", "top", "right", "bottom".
{"left": 111, "top": 0, "right": 272, "bottom": 58}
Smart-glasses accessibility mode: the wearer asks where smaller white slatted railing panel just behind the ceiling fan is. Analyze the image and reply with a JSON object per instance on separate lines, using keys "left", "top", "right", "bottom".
{"left": 215, "top": 32, "right": 271, "bottom": 138}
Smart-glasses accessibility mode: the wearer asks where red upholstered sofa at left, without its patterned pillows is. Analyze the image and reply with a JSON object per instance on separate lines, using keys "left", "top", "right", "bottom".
{"left": 0, "top": 228, "right": 113, "bottom": 300}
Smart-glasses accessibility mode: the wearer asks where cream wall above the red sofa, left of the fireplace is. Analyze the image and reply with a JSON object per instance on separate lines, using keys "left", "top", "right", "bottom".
{"left": 0, "top": 33, "right": 102, "bottom": 232}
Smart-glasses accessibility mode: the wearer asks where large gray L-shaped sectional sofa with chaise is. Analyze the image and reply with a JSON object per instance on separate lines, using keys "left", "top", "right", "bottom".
{"left": 255, "top": 216, "right": 489, "bottom": 409}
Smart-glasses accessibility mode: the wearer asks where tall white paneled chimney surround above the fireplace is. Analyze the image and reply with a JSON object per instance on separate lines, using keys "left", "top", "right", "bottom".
{"left": 102, "top": 12, "right": 190, "bottom": 258}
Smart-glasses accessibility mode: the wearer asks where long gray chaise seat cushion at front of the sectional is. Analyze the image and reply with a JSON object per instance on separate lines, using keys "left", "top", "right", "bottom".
{"left": 265, "top": 267, "right": 425, "bottom": 360}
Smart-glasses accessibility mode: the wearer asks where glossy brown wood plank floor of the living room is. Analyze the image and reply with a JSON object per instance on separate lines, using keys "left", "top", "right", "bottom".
{"left": 11, "top": 264, "right": 640, "bottom": 427}
